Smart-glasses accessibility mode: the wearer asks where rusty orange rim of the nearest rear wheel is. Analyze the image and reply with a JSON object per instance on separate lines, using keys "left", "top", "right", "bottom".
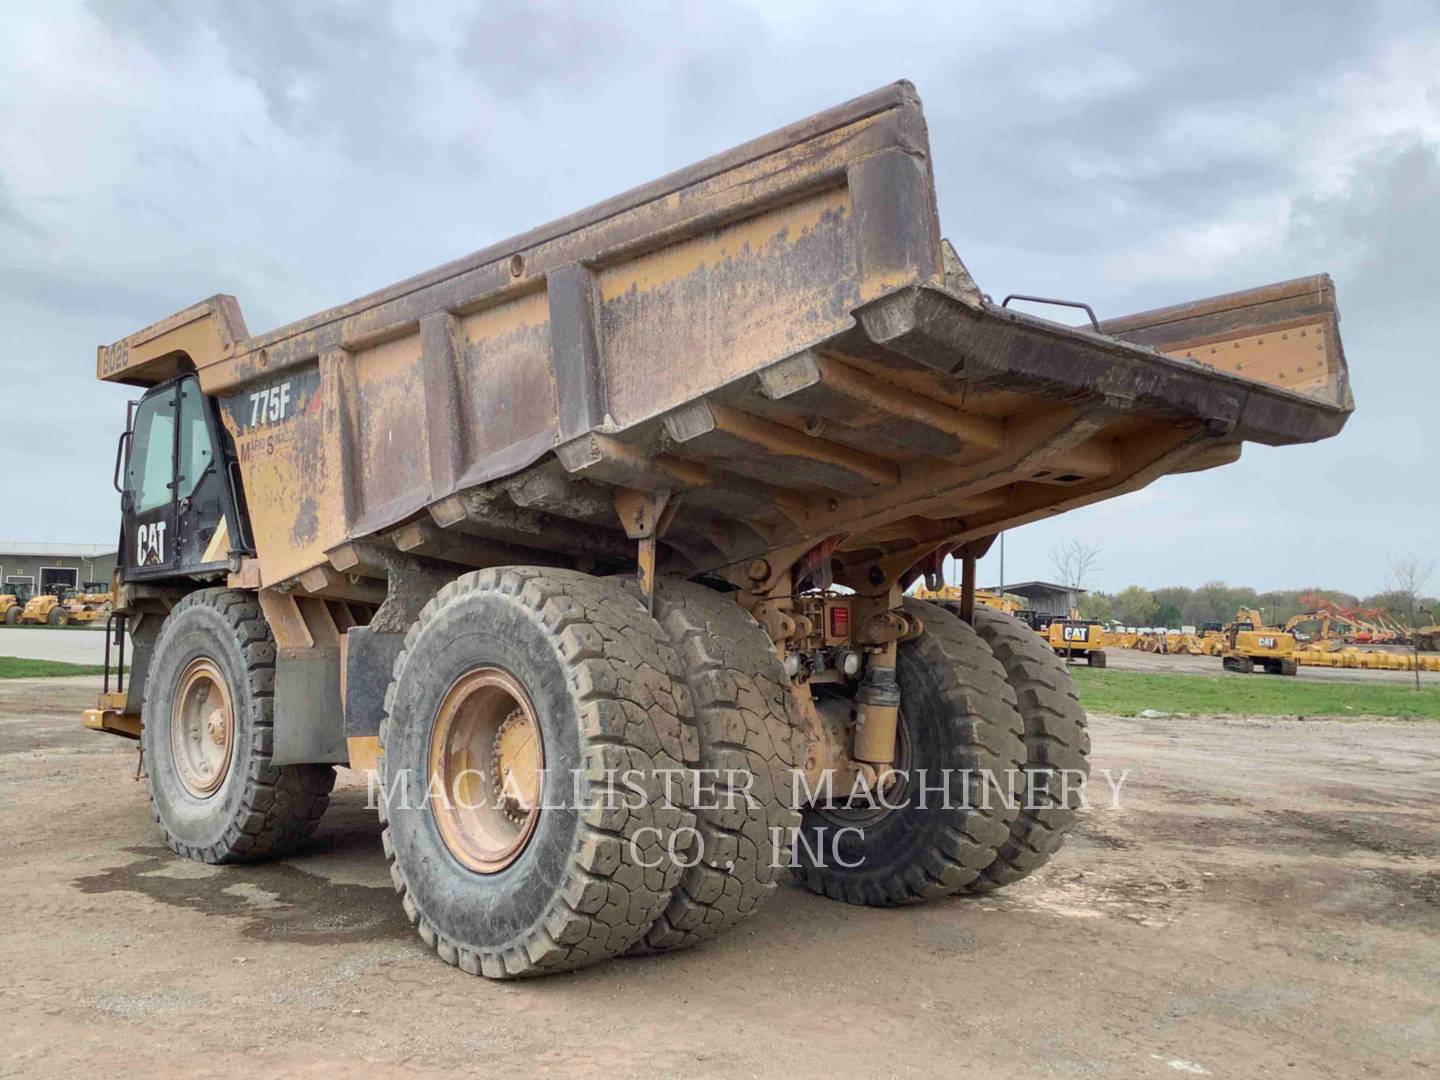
{"left": 426, "top": 667, "right": 544, "bottom": 874}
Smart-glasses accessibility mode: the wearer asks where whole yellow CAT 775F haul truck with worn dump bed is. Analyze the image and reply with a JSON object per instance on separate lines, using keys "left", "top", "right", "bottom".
{"left": 86, "top": 84, "right": 1352, "bottom": 978}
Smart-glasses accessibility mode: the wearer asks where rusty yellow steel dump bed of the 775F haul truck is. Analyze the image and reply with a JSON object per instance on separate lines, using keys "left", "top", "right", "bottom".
{"left": 98, "top": 84, "right": 1354, "bottom": 598}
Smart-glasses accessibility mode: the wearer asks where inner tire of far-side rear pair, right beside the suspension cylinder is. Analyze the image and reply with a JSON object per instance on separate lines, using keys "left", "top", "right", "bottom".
{"left": 793, "top": 599, "right": 1025, "bottom": 907}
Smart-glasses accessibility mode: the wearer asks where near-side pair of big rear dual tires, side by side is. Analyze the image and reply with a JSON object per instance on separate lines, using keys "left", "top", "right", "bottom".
{"left": 380, "top": 567, "right": 802, "bottom": 979}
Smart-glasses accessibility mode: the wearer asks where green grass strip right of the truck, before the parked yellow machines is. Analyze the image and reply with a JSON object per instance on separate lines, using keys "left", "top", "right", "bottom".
{"left": 1071, "top": 668, "right": 1440, "bottom": 720}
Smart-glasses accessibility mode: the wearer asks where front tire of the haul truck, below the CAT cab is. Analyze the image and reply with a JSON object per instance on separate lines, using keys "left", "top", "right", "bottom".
{"left": 140, "top": 589, "right": 336, "bottom": 863}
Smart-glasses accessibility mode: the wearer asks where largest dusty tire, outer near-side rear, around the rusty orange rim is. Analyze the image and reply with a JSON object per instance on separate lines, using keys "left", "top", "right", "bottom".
{"left": 380, "top": 567, "right": 696, "bottom": 979}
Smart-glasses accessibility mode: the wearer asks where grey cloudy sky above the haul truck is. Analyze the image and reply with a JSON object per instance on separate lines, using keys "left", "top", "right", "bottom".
{"left": 0, "top": 0, "right": 1440, "bottom": 593}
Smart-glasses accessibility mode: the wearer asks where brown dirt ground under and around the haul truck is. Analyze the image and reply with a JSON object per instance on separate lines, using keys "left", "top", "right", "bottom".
{"left": 0, "top": 680, "right": 1440, "bottom": 1077}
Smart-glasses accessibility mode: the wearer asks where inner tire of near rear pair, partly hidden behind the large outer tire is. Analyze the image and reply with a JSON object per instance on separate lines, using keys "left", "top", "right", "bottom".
{"left": 632, "top": 582, "right": 805, "bottom": 952}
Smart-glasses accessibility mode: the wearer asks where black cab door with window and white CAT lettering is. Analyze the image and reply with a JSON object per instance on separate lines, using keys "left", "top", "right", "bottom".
{"left": 120, "top": 382, "right": 180, "bottom": 580}
